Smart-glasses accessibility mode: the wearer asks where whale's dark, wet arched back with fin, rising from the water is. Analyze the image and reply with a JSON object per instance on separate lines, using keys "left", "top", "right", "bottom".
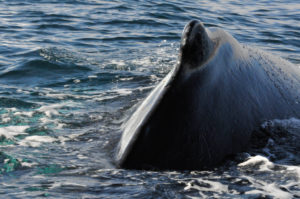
{"left": 116, "top": 21, "right": 300, "bottom": 170}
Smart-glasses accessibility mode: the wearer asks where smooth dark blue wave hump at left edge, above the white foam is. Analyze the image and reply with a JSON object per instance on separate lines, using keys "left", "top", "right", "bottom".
{"left": 0, "top": 48, "right": 91, "bottom": 85}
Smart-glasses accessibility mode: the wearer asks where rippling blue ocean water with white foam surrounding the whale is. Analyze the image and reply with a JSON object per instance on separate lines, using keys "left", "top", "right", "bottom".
{"left": 0, "top": 0, "right": 300, "bottom": 198}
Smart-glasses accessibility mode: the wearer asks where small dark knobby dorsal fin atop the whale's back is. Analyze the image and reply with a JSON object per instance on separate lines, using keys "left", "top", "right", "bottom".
{"left": 180, "top": 20, "right": 214, "bottom": 68}
